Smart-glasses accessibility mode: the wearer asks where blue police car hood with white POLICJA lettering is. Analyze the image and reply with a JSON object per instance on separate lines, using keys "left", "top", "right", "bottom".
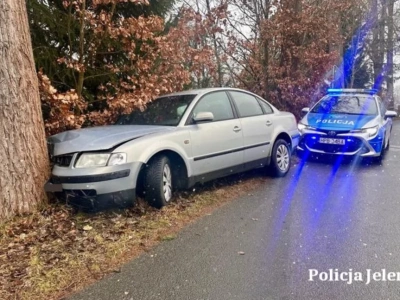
{"left": 301, "top": 113, "right": 377, "bottom": 130}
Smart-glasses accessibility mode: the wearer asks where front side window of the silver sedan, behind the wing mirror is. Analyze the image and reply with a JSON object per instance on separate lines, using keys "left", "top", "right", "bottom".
{"left": 192, "top": 92, "right": 234, "bottom": 121}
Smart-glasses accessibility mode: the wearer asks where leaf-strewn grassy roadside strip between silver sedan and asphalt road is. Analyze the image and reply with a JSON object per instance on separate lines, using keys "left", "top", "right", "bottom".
{"left": 0, "top": 171, "right": 269, "bottom": 300}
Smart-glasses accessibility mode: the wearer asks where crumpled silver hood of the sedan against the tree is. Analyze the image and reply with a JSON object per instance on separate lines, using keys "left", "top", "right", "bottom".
{"left": 47, "top": 125, "right": 175, "bottom": 156}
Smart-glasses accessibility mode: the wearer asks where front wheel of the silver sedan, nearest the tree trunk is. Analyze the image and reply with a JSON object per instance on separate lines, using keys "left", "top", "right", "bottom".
{"left": 144, "top": 156, "right": 173, "bottom": 208}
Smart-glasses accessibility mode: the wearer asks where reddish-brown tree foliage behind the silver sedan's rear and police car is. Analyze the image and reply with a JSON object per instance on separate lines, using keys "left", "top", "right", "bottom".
{"left": 230, "top": 0, "right": 356, "bottom": 115}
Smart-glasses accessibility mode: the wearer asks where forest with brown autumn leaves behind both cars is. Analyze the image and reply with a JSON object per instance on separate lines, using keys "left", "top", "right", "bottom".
{"left": 27, "top": 0, "right": 400, "bottom": 135}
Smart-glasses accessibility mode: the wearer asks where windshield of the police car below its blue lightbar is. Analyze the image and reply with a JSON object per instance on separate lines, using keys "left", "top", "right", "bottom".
{"left": 311, "top": 95, "right": 378, "bottom": 115}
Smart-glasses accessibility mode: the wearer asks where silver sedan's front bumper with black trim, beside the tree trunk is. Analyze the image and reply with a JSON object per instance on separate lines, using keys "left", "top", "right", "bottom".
{"left": 45, "top": 162, "right": 142, "bottom": 207}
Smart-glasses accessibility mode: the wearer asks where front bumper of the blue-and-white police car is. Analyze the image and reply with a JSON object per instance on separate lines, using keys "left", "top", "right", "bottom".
{"left": 297, "top": 130, "right": 383, "bottom": 157}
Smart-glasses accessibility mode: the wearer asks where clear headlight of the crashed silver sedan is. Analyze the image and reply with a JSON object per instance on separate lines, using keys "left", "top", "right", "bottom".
{"left": 75, "top": 153, "right": 126, "bottom": 168}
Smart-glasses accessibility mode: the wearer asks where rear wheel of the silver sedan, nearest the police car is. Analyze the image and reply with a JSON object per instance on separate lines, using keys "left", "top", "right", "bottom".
{"left": 270, "top": 140, "right": 291, "bottom": 177}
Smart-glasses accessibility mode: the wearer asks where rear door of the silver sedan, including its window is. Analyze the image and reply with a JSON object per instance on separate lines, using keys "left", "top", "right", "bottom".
{"left": 229, "top": 91, "right": 274, "bottom": 168}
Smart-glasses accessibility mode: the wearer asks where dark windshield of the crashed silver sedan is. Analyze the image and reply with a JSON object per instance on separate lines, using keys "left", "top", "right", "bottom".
{"left": 115, "top": 95, "right": 196, "bottom": 126}
